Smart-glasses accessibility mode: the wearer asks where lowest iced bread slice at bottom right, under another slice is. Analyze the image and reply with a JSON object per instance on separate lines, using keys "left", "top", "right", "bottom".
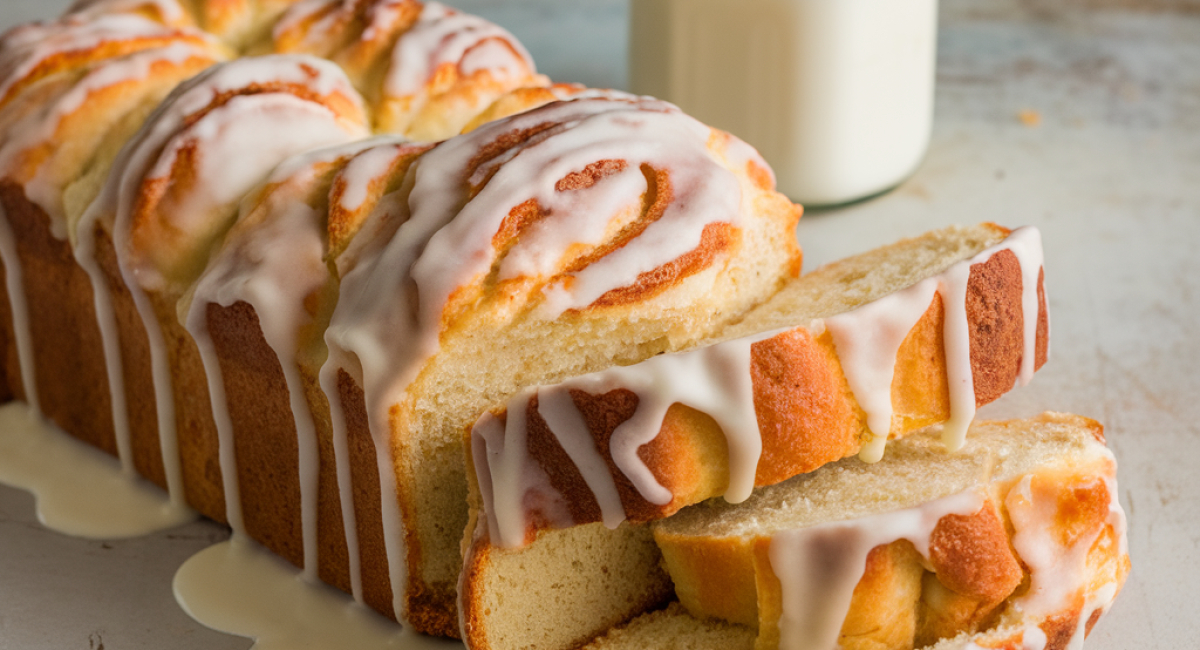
{"left": 654, "top": 413, "right": 1129, "bottom": 650}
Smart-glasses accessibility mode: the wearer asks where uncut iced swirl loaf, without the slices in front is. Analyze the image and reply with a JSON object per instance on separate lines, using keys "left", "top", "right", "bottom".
{"left": 0, "top": 0, "right": 799, "bottom": 634}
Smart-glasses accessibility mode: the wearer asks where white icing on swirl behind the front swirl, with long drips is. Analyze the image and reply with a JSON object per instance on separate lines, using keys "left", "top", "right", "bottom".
{"left": 76, "top": 56, "right": 365, "bottom": 513}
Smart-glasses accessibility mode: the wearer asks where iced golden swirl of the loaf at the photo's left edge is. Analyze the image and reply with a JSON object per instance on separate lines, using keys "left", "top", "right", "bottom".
{"left": 0, "top": 16, "right": 230, "bottom": 239}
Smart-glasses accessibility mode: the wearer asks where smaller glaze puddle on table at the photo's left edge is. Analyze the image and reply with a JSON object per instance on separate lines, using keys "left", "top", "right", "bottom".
{"left": 0, "top": 402, "right": 196, "bottom": 540}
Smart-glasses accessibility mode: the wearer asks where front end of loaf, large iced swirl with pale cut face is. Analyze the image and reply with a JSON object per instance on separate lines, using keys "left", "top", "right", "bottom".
{"left": 322, "top": 98, "right": 799, "bottom": 634}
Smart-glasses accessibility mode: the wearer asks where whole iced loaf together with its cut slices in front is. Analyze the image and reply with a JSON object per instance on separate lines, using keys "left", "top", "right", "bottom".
{"left": 0, "top": 0, "right": 1128, "bottom": 649}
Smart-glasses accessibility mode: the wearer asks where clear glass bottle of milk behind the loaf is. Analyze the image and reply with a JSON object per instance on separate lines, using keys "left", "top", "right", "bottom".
{"left": 630, "top": 0, "right": 937, "bottom": 205}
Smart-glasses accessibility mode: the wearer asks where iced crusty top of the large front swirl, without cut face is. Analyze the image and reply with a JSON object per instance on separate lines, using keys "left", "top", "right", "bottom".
{"left": 331, "top": 91, "right": 790, "bottom": 426}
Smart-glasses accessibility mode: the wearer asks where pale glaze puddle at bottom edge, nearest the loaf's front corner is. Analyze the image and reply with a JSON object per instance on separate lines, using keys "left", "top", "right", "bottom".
{"left": 174, "top": 535, "right": 462, "bottom": 650}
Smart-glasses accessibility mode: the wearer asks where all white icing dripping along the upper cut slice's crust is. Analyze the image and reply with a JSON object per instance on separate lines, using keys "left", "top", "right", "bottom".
{"left": 472, "top": 226, "right": 1042, "bottom": 546}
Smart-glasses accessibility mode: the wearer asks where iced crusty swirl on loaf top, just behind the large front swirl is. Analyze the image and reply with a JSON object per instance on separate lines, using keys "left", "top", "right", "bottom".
{"left": 79, "top": 55, "right": 368, "bottom": 293}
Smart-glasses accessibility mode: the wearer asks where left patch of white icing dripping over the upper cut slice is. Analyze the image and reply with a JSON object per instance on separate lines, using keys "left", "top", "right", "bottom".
{"left": 472, "top": 332, "right": 776, "bottom": 548}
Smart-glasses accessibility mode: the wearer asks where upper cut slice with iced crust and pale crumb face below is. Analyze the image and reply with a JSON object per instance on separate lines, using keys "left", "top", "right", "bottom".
{"left": 460, "top": 224, "right": 1049, "bottom": 649}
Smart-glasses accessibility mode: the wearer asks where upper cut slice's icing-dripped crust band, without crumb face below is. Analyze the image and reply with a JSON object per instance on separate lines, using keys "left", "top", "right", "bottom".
{"left": 472, "top": 224, "right": 1045, "bottom": 547}
